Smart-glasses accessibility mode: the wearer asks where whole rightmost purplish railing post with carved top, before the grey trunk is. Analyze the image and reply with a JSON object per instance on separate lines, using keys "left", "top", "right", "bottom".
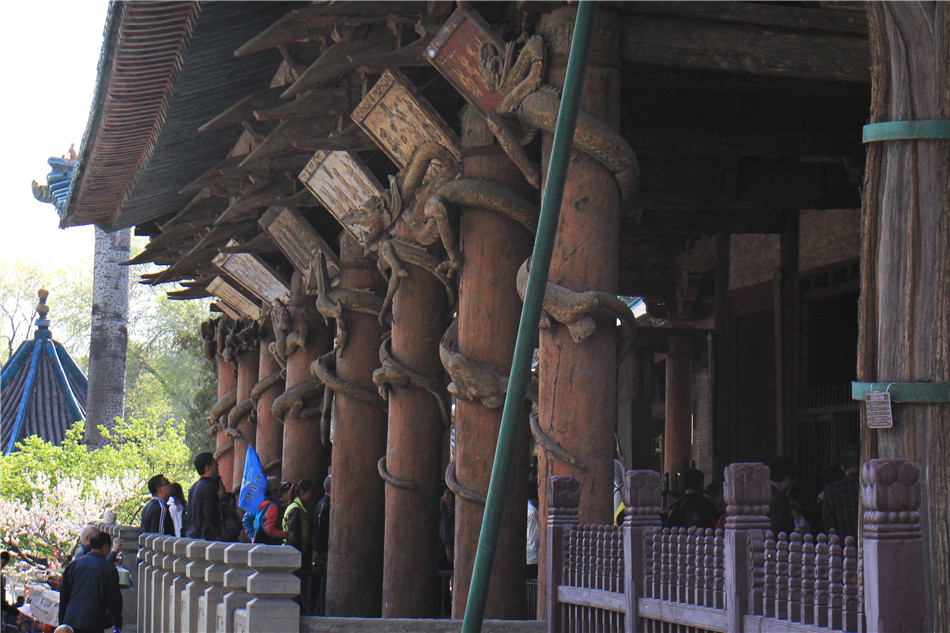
{"left": 861, "top": 459, "right": 924, "bottom": 633}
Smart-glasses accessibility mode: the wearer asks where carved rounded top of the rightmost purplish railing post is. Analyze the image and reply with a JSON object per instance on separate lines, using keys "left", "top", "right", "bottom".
{"left": 861, "top": 459, "right": 920, "bottom": 539}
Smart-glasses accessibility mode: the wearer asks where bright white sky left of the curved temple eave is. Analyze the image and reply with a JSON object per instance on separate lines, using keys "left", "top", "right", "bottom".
{"left": 0, "top": 0, "right": 108, "bottom": 268}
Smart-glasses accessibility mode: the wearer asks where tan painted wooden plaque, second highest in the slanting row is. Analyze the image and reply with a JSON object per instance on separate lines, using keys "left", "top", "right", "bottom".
{"left": 350, "top": 68, "right": 462, "bottom": 169}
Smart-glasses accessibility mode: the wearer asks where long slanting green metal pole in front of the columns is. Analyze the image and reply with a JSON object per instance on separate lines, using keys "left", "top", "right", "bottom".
{"left": 462, "top": 0, "right": 597, "bottom": 633}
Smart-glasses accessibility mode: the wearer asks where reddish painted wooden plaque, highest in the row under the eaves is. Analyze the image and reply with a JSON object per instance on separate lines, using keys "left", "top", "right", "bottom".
{"left": 425, "top": 7, "right": 505, "bottom": 114}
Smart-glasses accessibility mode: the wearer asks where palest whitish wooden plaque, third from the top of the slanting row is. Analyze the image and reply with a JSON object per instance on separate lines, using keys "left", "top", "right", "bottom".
{"left": 299, "top": 150, "right": 383, "bottom": 243}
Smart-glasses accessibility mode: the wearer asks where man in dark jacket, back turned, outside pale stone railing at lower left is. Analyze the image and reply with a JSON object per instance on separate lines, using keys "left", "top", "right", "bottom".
{"left": 59, "top": 532, "right": 122, "bottom": 633}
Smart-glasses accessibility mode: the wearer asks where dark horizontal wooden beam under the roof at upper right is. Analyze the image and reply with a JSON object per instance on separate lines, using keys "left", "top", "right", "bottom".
{"left": 621, "top": 10, "right": 870, "bottom": 83}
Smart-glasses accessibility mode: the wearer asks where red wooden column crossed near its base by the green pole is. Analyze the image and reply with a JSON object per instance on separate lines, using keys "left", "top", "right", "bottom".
{"left": 452, "top": 107, "right": 537, "bottom": 619}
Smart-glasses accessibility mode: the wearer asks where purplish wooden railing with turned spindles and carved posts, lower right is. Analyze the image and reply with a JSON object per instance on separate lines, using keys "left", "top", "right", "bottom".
{"left": 545, "top": 460, "right": 924, "bottom": 633}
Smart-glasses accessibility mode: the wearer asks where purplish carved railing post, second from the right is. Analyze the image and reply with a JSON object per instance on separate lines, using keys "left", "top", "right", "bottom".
{"left": 724, "top": 463, "right": 771, "bottom": 633}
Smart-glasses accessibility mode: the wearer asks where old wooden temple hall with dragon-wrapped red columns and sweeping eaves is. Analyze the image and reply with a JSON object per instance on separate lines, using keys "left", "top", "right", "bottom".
{"left": 61, "top": 1, "right": 950, "bottom": 630}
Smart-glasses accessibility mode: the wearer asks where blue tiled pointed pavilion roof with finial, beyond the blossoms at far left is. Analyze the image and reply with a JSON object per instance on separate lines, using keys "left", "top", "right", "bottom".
{"left": 0, "top": 290, "right": 88, "bottom": 455}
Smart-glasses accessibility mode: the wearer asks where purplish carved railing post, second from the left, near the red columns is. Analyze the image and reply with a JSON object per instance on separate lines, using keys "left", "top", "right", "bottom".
{"left": 623, "top": 470, "right": 661, "bottom": 633}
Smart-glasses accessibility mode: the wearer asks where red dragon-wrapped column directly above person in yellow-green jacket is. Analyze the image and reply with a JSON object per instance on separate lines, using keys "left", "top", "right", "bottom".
{"left": 281, "top": 273, "right": 333, "bottom": 484}
